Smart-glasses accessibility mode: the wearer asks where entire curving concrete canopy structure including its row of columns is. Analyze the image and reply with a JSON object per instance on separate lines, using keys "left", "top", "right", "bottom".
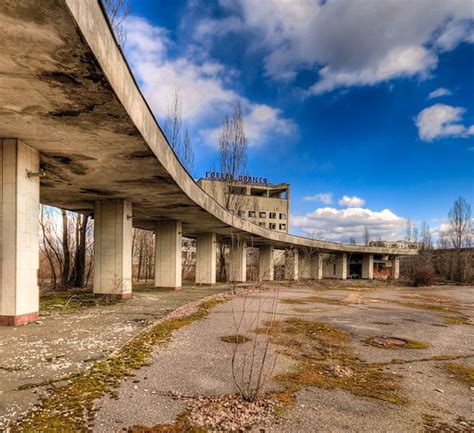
{"left": 0, "top": 0, "right": 416, "bottom": 324}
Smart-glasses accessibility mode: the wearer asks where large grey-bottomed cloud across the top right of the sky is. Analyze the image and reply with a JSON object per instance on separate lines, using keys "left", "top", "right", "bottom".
{"left": 204, "top": 0, "right": 474, "bottom": 94}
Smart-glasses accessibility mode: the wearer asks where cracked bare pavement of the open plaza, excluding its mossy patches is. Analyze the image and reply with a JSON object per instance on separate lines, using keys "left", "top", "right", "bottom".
{"left": 95, "top": 282, "right": 474, "bottom": 433}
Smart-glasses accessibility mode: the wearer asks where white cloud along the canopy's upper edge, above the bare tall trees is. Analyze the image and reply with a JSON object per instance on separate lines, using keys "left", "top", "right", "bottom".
{"left": 124, "top": 16, "right": 296, "bottom": 146}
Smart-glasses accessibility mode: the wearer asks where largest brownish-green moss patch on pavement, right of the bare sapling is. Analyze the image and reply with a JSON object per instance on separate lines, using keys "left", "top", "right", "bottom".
{"left": 259, "top": 318, "right": 408, "bottom": 415}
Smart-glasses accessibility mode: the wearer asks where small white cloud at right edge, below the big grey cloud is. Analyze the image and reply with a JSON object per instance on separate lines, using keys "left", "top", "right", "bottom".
{"left": 415, "top": 104, "right": 474, "bottom": 141}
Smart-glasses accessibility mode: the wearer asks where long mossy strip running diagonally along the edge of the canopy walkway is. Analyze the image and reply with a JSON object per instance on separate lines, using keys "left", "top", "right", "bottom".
{"left": 12, "top": 299, "right": 224, "bottom": 432}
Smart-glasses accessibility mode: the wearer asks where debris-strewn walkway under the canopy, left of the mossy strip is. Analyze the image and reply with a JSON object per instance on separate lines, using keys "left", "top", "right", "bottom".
{"left": 0, "top": 286, "right": 230, "bottom": 431}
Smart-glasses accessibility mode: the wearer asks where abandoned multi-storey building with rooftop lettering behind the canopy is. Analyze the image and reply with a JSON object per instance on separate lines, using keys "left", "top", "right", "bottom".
{"left": 198, "top": 173, "right": 290, "bottom": 233}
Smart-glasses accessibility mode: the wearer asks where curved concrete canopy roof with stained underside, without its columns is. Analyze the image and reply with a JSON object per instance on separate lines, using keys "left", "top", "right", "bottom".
{"left": 0, "top": 0, "right": 416, "bottom": 255}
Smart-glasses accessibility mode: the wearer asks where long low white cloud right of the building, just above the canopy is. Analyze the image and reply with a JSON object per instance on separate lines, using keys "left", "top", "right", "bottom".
{"left": 291, "top": 207, "right": 406, "bottom": 242}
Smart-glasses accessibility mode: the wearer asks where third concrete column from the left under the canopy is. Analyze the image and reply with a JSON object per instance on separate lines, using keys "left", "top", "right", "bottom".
{"left": 155, "top": 221, "right": 183, "bottom": 290}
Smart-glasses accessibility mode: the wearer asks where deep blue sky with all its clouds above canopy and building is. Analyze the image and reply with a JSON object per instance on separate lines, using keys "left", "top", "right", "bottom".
{"left": 124, "top": 0, "right": 474, "bottom": 242}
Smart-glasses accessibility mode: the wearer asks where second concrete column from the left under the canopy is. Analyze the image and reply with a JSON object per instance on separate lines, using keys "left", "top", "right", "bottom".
{"left": 94, "top": 200, "right": 132, "bottom": 299}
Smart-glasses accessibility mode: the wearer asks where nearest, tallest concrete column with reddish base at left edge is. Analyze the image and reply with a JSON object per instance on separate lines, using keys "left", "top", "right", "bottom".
{"left": 0, "top": 138, "right": 40, "bottom": 326}
